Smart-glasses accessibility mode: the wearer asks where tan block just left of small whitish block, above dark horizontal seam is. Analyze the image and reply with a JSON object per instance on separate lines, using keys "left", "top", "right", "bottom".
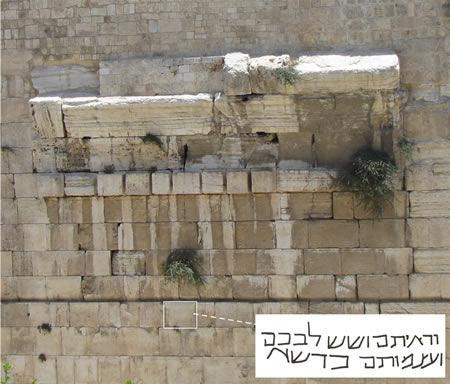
{"left": 297, "top": 275, "right": 336, "bottom": 300}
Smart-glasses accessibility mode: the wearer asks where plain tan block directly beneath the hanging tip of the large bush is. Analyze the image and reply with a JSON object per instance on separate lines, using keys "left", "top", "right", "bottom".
{"left": 359, "top": 219, "right": 405, "bottom": 248}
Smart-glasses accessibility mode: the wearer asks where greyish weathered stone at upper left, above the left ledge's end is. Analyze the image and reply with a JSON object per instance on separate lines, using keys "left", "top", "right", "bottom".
{"left": 31, "top": 65, "right": 99, "bottom": 96}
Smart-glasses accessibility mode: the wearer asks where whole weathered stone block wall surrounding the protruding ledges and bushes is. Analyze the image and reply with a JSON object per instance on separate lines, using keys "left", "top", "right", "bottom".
{"left": 1, "top": 0, "right": 450, "bottom": 384}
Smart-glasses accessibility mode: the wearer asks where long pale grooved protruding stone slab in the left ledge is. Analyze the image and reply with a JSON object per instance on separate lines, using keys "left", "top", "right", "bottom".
{"left": 62, "top": 94, "right": 212, "bottom": 137}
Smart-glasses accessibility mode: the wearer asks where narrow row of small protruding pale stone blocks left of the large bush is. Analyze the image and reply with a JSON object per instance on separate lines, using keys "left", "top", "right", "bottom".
{"left": 36, "top": 169, "right": 336, "bottom": 197}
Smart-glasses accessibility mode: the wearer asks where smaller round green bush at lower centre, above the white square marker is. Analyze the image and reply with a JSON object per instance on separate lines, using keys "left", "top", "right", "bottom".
{"left": 164, "top": 249, "right": 203, "bottom": 285}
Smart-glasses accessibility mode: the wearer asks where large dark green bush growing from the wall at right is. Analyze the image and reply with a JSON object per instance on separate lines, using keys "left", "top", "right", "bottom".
{"left": 335, "top": 148, "right": 397, "bottom": 217}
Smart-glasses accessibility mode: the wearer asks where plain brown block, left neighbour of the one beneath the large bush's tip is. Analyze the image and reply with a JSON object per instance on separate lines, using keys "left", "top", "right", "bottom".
{"left": 308, "top": 220, "right": 359, "bottom": 248}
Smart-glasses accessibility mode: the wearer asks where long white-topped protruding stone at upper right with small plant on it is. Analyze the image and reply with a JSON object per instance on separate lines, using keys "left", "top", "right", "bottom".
{"left": 249, "top": 53, "right": 400, "bottom": 94}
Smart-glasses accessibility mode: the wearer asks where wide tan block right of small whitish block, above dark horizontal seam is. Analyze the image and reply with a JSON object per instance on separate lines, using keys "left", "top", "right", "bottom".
{"left": 357, "top": 275, "right": 409, "bottom": 300}
